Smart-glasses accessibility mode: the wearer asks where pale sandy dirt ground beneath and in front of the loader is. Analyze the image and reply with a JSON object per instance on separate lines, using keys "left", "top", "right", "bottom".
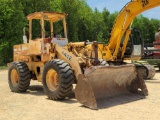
{"left": 0, "top": 70, "right": 160, "bottom": 120}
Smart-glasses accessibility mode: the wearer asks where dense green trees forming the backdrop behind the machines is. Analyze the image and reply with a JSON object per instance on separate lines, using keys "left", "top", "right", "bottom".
{"left": 0, "top": 0, "right": 160, "bottom": 66}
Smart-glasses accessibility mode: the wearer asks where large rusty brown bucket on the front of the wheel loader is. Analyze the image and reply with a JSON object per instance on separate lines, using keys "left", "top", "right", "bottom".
{"left": 75, "top": 64, "right": 148, "bottom": 109}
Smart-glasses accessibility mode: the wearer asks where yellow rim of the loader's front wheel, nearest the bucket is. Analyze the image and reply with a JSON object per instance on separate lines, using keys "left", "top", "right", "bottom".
{"left": 46, "top": 69, "right": 58, "bottom": 91}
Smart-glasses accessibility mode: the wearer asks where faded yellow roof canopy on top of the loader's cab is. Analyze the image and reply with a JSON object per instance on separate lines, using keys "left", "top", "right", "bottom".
{"left": 27, "top": 12, "right": 67, "bottom": 22}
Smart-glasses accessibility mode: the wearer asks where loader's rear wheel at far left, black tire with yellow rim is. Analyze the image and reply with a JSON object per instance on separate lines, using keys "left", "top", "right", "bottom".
{"left": 8, "top": 62, "right": 31, "bottom": 93}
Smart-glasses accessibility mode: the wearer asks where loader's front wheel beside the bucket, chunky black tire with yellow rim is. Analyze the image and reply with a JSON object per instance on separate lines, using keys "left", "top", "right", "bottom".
{"left": 42, "top": 59, "right": 75, "bottom": 100}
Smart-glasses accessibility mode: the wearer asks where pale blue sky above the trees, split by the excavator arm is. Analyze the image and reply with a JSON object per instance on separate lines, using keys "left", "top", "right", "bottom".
{"left": 87, "top": 0, "right": 160, "bottom": 20}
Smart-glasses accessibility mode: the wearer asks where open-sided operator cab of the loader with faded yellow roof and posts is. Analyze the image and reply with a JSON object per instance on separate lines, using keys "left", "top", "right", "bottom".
{"left": 24, "top": 12, "right": 68, "bottom": 49}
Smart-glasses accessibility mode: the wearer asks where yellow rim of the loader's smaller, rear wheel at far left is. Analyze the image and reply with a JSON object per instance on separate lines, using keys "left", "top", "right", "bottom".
{"left": 11, "top": 69, "right": 19, "bottom": 86}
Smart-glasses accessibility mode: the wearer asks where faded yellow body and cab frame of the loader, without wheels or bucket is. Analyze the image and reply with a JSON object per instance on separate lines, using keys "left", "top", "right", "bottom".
{"left": 12, "top": 12, "right": 81, "bottom": 81}
